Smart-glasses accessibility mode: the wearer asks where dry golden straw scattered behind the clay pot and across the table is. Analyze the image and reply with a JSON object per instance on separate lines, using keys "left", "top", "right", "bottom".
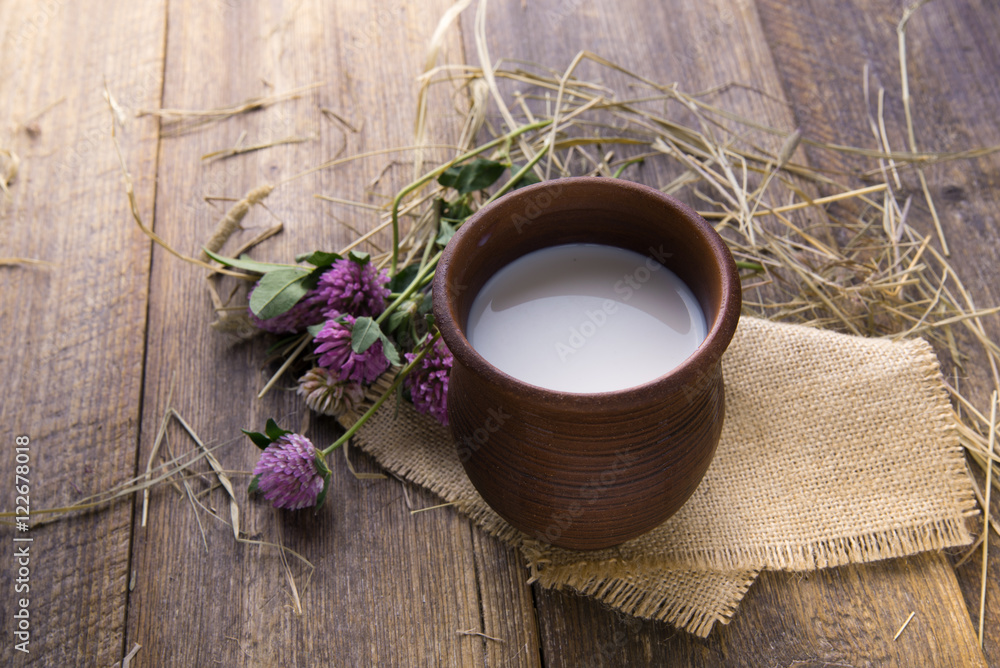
{"left": 0, "top": 2, "right": 1000, "bottom": 636}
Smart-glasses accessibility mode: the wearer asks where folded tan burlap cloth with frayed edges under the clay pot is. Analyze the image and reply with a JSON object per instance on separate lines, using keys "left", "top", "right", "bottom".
{"left": 341, "top": 317, "right": 976, "bottom": 636}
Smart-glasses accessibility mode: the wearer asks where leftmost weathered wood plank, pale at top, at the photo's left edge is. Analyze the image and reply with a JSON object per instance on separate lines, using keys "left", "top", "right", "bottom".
{"left": 0, "top": 0, "right": 164, "bottom": 666}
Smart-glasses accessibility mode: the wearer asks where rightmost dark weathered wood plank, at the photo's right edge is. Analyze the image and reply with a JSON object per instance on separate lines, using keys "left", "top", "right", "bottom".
{"left": 758, "top": 0, "right": 1000, "bottom": 664}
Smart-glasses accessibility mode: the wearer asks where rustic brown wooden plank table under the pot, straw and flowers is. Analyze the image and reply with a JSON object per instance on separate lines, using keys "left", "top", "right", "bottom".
{"left": 0, "top": 0, "right": 1000, "bottom": 668}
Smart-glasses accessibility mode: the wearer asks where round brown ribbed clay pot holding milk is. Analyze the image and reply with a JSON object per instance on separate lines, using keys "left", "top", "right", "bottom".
{"left": 433, "top": 177, "right": 741, "bottom": 549}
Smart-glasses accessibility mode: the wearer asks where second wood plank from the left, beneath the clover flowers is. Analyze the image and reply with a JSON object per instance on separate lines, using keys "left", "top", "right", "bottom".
{"left": 128, "top": 0, "right": 538, "bottom": 665}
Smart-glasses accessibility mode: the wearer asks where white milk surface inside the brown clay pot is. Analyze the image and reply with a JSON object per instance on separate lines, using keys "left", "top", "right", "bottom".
{"left": 466, "top": 244, "right": 707, "bottom": 393}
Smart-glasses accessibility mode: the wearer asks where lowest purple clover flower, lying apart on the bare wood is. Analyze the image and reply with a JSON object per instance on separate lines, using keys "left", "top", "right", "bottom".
{"left": 253, "top": 434, "right": 329, "bottom": 510}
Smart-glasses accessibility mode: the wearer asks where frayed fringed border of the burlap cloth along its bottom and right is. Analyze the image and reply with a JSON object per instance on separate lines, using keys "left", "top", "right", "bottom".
{"left": 340, "top": 320, "right": 977, "bottom": 636}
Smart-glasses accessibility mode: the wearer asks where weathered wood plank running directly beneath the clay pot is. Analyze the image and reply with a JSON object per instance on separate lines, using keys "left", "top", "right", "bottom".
{"left": 465, "top": 0, "right": 982, "bottom": 666}
